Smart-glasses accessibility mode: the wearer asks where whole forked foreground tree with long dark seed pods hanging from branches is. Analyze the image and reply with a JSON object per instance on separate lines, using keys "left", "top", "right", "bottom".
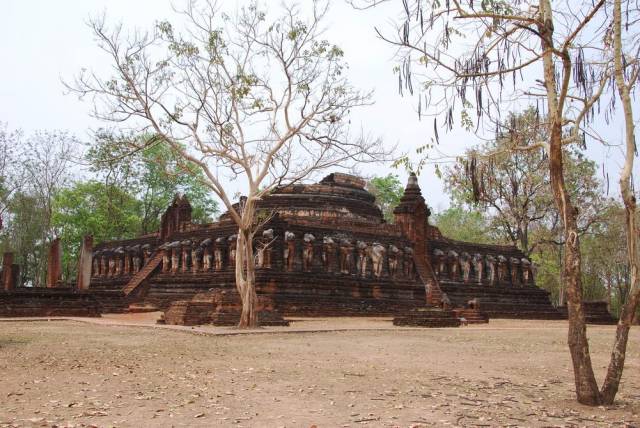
{"left": 358, "top": 0, "right": 638, "bottom": 405}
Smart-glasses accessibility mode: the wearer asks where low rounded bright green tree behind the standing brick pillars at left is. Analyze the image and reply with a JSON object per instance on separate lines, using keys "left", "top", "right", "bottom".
{"left": 52, "top": 181, "right": 141, "bottom": 279}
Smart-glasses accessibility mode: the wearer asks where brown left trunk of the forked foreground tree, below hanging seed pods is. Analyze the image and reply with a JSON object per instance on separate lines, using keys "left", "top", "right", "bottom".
{"left": 539, "top": 0, "right": 601, "bottom": 405}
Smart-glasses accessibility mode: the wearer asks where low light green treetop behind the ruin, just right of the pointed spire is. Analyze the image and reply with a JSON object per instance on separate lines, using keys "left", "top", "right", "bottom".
{"left": 434, "top": 205, "right": 499, "bottom": 244}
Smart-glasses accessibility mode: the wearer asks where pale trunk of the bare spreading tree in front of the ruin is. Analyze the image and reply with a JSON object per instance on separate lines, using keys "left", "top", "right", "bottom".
{"left": 236, "top": 226, "right": 258, "bottom": 328}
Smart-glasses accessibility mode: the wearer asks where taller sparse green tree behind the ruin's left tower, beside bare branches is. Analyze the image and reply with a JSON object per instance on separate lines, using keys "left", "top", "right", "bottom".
{"left": 87, "top": 130, "right": 218, "bottom": 234}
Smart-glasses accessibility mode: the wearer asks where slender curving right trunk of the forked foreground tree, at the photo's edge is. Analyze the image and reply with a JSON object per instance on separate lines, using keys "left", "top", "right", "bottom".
{"left": 601, "top": 0, "right": 640, "bottom": 404}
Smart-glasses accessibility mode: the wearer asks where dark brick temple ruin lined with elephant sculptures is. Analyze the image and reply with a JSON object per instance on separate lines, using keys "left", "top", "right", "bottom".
{"left": 79, "top": 173, "right": 559, "bottom": 318}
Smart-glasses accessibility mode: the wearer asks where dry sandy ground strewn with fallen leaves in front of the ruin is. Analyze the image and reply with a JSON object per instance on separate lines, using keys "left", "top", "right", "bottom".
{"left": 0, "top": 317, "right": 640, "bottom": 428}
